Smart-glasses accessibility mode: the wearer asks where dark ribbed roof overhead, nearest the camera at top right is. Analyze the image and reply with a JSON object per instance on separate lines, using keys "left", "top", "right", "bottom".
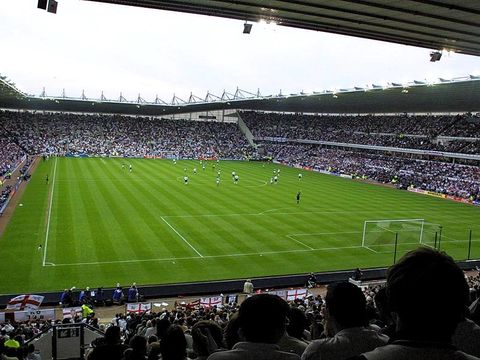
{"left": 89, "top": 0, "right": 480, "bottom": 56}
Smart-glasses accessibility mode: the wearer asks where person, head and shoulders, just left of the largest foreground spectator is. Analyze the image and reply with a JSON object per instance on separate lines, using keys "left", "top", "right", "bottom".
{"left": 302, "top": 282, "right": 388, "bottom": 360}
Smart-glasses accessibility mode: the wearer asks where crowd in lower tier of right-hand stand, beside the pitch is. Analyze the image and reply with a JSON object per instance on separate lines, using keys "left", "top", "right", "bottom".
{"left": 264, "top": 143, "right": 480, "bottom": 199}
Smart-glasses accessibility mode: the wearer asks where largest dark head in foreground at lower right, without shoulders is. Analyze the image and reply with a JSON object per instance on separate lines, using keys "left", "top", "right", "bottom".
{"left": 387, "top": 247, "right": 469, "bottom": 342}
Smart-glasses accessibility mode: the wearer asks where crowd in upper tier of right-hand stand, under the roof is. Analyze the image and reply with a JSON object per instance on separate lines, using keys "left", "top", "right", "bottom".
{"left": 241, "top": 112, "right": 480, "bottom": 154}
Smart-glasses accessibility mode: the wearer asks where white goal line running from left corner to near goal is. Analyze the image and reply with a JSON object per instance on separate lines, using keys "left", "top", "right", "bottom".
{"left": 46, "top": 245, "right": 364, "bottom": 266}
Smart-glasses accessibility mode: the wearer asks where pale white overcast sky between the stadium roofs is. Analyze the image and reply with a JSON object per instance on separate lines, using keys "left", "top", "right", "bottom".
{"left": 0, "top": 0, "right": 480, "bottom": 101}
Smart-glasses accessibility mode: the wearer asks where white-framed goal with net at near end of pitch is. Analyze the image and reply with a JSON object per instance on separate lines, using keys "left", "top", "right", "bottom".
{"left": 362, "top": 219, "right": 440, "bottom": 252}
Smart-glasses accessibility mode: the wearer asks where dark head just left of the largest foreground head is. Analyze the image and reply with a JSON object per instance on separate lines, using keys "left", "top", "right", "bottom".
{"left": 325, "top": 282, "right": 367, "bottom": 333}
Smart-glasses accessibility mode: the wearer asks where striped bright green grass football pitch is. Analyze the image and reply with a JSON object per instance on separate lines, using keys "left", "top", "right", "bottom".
{"left": 0, "top": 158, "right": 480, "bottom": 294}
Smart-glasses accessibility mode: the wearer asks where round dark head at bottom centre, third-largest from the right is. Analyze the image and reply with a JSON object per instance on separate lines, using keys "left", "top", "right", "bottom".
{"left": 238, "top": 294, "right": 289, "bottom": 344}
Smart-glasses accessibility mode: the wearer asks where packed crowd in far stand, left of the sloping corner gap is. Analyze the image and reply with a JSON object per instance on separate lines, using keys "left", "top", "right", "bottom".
{"left": 0, "top": 112, "right": 252, "bottom": 159}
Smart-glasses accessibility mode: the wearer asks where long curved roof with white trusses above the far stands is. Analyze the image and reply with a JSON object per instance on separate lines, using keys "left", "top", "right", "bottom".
{"left": 0, "top": 76, "right": 480, "bottom": 116}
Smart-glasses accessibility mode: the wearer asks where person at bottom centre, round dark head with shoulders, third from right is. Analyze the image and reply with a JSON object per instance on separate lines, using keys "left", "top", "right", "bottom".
{"left": 208, "top": 294, "right": 300, "bottom": 360}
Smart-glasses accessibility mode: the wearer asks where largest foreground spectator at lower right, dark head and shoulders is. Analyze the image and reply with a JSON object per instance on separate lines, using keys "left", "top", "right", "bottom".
{"left": 350, "top": 247, "right": 478, "bottom": 360}
